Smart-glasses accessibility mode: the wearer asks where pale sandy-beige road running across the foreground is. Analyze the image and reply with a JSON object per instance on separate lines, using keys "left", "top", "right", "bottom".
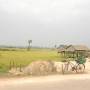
{"left": 0, "top": 75, "right": 90, "bottom": 90}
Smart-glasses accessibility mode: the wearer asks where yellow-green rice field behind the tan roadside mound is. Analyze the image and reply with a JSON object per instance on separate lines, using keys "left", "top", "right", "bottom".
{"left": 0, "top": 49, "right": 61, "bottom": 72}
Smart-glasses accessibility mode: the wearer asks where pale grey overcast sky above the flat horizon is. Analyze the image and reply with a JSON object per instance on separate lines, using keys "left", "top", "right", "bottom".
{"left": 0, "top": 0, "right": 90, "bottom": 47}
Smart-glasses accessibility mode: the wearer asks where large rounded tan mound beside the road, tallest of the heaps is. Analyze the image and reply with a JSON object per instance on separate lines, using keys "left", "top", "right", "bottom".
{"left": 23, "top": 61, "right": 54, "bottom": 75}
